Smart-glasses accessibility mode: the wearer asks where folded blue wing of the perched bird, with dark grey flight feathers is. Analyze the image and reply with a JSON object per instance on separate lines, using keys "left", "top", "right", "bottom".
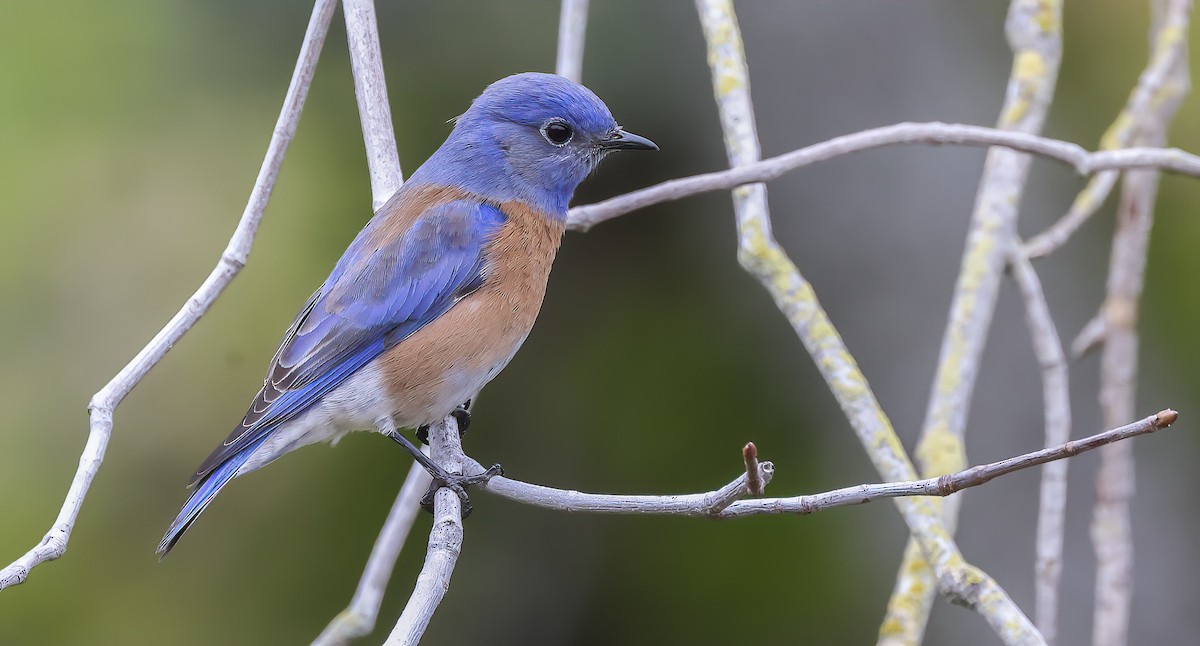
{"left": 192, "top": 201, "right": 505, "bottom": 484}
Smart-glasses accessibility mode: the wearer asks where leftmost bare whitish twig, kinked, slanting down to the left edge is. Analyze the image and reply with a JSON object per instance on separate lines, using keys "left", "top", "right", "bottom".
{"left": 0, "top": 0, "right": 337, "bottom": 590}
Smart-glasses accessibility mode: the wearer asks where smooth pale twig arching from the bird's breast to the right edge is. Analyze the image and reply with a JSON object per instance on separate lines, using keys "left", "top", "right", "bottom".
{"left": 568, "top": 121, "right": 1200, "bottom": 231}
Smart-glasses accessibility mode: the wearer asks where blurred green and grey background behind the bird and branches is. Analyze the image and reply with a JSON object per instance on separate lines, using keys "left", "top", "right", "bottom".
{"left": 0, "top": 0, "right": 1200, "bottom": 645}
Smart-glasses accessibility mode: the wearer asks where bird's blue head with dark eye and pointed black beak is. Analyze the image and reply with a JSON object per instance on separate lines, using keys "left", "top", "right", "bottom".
{"left": 414, "top": 72, "right": 658, "bottom": 217}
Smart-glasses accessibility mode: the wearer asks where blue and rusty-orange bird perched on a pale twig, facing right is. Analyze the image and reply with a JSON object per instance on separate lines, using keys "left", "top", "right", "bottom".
{"left": 157, "top": 72, "right": 658, "bottom": 556}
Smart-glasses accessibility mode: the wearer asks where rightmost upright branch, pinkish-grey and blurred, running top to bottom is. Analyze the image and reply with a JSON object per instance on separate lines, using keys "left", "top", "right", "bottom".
{"left": 1091, "top": 6, "right": 1192, "bottom": 646}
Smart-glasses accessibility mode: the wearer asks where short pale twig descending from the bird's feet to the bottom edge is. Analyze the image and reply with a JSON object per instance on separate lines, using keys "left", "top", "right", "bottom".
{"left": 384, "top": 415, "right": 463, "bottom": 646}
